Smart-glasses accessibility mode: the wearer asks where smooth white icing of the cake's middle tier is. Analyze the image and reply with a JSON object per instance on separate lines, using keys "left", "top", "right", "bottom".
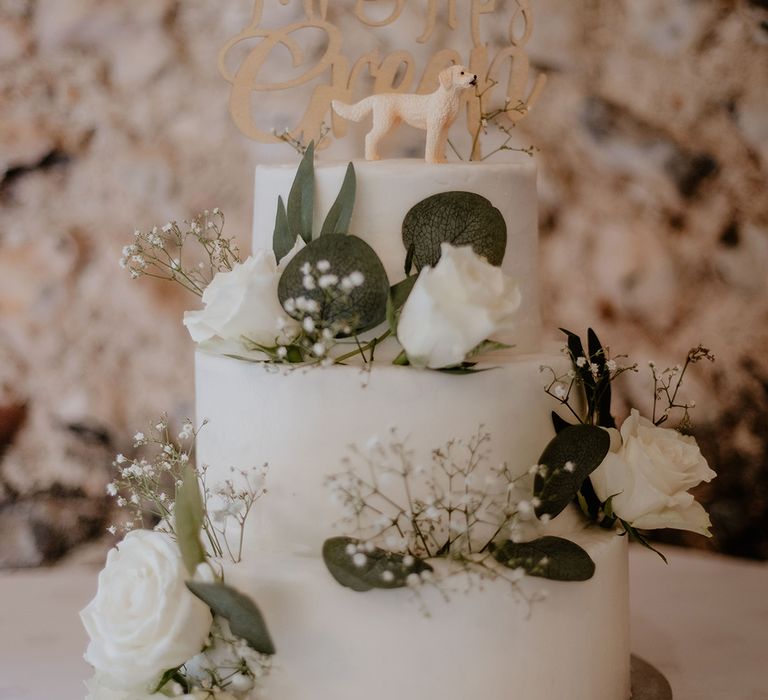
{"left": 196, "top": 350, "right": 568, "bottom": 554}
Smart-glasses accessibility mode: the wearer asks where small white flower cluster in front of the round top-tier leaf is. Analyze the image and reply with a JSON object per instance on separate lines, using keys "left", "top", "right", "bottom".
{"left": 276, "top": 260, "right": 365, "bottom": 365}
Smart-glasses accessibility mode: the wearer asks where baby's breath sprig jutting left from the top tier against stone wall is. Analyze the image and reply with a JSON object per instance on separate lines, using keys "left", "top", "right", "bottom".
{"left": 120, "top": 209, "right": 240, "bottom": 296}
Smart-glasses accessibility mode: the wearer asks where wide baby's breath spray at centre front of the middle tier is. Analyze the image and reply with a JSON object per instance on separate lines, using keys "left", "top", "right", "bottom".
{"left": 327, "top": 426, "right": 536, "bottom": 602}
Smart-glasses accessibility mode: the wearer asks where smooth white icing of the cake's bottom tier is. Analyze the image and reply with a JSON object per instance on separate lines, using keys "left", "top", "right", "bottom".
{"left": 226, "top": 514, "right": 630, "bottom": 700}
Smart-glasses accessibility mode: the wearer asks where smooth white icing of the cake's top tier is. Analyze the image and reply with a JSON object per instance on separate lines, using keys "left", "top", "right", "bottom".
{"left": 253, "top": 159, "right": 541, "bottom": 353}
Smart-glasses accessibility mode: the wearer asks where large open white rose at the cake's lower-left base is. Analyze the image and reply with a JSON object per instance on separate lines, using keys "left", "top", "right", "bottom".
{"left": 80, "top": 530, "right": 212, "bottom": 688}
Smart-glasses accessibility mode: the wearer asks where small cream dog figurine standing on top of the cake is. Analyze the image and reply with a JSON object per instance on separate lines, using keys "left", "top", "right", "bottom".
{"left": 331, "top": 66, "right": 477, "bottom": 163}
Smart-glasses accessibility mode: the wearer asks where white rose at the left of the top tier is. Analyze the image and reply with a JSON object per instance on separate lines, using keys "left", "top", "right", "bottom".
{"left": 184, "top": 245, "right": 303, "bottom": 346}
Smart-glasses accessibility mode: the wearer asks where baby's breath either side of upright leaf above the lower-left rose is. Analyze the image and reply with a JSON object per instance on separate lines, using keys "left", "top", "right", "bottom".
{"left": 107, "top": 416, "right": 266, "bottom": 563}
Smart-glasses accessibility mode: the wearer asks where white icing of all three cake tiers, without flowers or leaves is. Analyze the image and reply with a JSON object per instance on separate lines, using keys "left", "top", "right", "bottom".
{"left": 196, "top": 161, "right": 630, "bottom": 700}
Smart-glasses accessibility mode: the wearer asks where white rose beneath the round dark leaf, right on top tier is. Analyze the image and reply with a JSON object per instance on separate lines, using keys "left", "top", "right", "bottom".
{"left": 397, "top": 243, "right": 521, "bottom": 369}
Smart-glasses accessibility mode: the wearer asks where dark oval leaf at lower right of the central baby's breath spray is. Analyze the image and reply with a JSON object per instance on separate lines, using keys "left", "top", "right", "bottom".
{"left": 492, "top": 536, "right": 595, "bottom": 581}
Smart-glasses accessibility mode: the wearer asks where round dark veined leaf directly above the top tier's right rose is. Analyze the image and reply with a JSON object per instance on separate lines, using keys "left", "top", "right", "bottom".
{"left": 403, "top": 192, "right": 507, "bottom": 274}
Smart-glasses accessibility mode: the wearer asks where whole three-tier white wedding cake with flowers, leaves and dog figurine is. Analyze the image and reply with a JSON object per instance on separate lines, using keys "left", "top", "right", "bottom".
{"left": 82, "top": 3, "right": 714, "bottom": 700}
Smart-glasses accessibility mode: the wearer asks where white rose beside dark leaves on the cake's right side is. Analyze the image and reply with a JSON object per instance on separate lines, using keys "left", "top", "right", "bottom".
{"left": 591, "top": 409, "right": 716, "bottom": 535}
